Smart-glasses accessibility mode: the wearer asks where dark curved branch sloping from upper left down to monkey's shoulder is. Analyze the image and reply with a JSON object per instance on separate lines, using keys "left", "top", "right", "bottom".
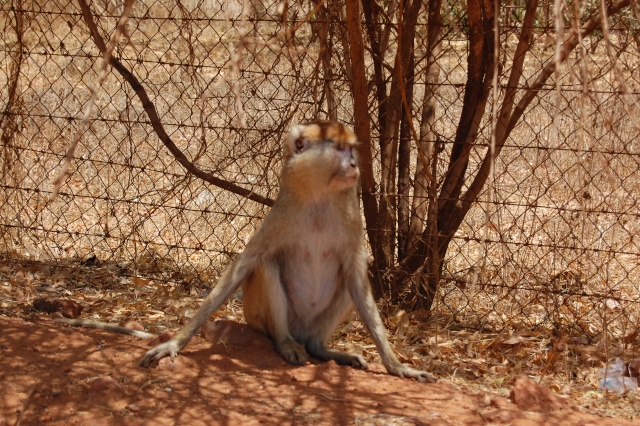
{"left": 77, "top": 0, "right": 274, "bottom": 206}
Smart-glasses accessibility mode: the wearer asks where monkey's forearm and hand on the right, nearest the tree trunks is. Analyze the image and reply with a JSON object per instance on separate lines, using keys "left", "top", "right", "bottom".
{"left": 347, "top": 265, "right": 436, "bottom": 383}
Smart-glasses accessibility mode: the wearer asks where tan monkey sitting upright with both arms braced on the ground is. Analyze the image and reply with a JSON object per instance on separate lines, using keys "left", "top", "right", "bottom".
{"left": 140, "top": 121, "right": 435, "bottom": 382}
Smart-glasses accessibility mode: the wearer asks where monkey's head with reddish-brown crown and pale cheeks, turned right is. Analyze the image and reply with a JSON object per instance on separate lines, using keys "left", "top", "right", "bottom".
{"left": 282, "top": 121, "right": 360, "bottom": 195}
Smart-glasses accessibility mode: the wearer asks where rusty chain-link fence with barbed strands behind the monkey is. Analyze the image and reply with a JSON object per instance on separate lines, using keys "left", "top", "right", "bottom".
{"left": 0, "top": 0, "right": 640, "bottom": 346}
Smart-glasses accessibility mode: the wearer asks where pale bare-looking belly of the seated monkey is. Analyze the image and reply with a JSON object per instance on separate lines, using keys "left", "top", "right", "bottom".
{"left": 283, "top": 243, "right": 342, "bottom": 318}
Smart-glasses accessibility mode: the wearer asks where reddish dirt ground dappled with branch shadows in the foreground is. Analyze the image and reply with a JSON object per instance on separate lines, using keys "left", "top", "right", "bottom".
{"left": 0, "top": 316, "right": 640, "bottom": 425}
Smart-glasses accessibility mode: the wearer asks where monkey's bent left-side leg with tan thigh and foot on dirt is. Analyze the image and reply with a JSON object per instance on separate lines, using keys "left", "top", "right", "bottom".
{"left": 243, "top": 262, "right": 309, "bottom": 365}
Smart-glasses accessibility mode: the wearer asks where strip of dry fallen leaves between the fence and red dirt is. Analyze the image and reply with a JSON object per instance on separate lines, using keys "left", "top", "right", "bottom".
{"left": 0, "top": 256, "right": 640, "bottom": 417}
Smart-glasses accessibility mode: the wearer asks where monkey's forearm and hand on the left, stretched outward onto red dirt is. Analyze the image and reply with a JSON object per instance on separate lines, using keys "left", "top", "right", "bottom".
{"left": 140, "top": 253, "right": 253, "bottom": 368}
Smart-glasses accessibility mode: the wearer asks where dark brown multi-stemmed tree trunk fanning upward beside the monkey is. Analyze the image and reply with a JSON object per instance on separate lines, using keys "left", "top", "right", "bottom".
{"left": 347, "top": 0, "right": 630, "bottom": 309}
